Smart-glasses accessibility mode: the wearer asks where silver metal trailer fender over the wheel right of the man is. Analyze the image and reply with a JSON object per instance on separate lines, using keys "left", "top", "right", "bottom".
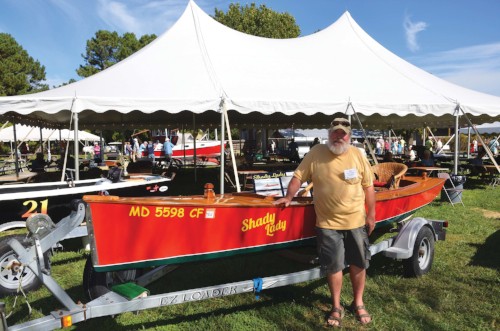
{"left": 383, "top": 217, "right": 436, "bottom": 260}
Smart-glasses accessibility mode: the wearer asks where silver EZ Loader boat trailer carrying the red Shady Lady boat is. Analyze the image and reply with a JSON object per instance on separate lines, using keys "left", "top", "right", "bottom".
{"left": 0, "top": 200, "right": 447, "bottom": 331}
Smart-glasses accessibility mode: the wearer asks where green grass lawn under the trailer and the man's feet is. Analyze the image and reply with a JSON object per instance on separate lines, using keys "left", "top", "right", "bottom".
{"left": 2, "top": 179, "right": 500, "bottom": 331}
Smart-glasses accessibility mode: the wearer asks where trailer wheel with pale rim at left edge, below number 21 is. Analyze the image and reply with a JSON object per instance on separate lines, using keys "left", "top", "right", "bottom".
{"left": 0, "top": 235, "right": 51, "bottom": 296}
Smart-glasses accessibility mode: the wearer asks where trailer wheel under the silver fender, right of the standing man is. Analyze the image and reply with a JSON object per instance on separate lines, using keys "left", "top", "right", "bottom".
{"left": 403, "top": 226, "right": 434, "bottom": 277}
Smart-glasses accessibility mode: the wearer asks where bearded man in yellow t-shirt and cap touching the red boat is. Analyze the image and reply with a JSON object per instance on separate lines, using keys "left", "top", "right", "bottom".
{"left": 275, "top": 118, "right": 375, "bottom": 327}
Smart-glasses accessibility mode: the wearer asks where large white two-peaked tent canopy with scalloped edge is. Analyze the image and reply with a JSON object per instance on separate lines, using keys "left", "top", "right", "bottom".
{"left": 0, "top": 1, "right": 500, "bottom": 129}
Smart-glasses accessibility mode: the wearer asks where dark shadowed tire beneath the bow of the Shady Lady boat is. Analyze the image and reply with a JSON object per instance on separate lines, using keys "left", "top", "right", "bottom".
{"left": 83, "top": 256, "right": 143, "bottom": 300}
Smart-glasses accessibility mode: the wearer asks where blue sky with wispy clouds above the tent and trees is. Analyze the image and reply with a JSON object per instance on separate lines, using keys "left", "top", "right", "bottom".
{"left": 0, "top": 0, "right": 500, "bottom": 96}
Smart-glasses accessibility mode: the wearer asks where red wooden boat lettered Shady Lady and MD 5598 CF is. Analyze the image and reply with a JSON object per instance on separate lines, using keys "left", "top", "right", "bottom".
{"left": 83, "top": 177, "right": 444, "bottom": 271}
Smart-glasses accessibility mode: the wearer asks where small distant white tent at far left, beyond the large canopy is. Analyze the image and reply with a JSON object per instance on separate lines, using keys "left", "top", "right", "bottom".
{"left": 0, "top": 124, "right": 100, "bottom": 142}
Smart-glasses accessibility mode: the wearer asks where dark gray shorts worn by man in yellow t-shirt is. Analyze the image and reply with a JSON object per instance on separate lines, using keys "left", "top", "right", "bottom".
{"left": 316, "top": 226, "right": 371, "bottom": 273}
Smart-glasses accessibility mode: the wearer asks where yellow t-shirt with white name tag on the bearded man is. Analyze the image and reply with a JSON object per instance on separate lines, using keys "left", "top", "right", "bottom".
{"left": 294, "top": 144, "right": 373, "bottom": 230}
